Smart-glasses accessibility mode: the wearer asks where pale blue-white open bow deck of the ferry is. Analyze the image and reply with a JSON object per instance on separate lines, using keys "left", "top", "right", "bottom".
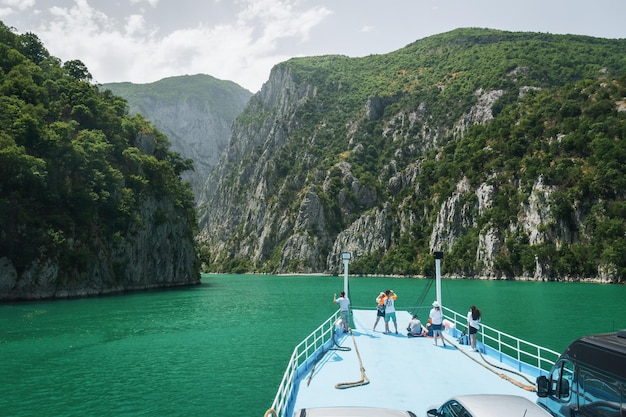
{"left": 294, "top": 310, "right": 537, "bottom": 415}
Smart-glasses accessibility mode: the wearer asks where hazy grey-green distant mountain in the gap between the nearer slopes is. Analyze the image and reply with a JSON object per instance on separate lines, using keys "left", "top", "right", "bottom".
{"left": 102, "top": 74, "right": 252, "bottom": 194}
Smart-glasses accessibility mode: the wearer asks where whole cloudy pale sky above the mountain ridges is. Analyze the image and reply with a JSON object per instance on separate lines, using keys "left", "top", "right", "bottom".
{"left": 0, "top": 0, "right": 626, "bottom": 93}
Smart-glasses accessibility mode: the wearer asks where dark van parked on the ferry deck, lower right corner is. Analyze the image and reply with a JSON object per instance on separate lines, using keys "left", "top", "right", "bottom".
{"left": 537, "top": 330, "right": 626, "bottom": 417}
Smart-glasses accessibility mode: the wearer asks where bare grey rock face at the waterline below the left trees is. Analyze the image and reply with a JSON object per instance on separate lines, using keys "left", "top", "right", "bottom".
{"left": 0, "top": 195, "right": 200, "bottom": 300}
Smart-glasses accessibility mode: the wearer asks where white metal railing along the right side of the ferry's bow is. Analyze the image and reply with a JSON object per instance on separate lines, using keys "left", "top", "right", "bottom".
{"left": 443, "top": 307, "right": 560, "bottom": 375}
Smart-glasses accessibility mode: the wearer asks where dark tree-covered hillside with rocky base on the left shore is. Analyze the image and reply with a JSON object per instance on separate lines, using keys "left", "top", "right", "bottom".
{"left": 0, "top": 23, "right": 200, "bottom": 300}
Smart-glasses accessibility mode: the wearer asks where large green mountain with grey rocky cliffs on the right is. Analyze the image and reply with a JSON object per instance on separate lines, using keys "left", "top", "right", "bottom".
{"left": 199, "top": 29, "right": 626, "bottom": 282}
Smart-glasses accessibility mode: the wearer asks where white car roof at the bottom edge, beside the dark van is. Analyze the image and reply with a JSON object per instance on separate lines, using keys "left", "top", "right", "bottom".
{"left": 452, "top": 394, "right": 550, "bottom": 417}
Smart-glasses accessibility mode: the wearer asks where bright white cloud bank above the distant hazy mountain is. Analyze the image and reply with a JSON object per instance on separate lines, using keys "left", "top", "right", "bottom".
{"left": 20, "top": 0, "right": 331, "bottom": 92}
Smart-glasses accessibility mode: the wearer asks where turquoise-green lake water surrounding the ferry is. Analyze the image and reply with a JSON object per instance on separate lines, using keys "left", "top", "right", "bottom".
{"left": 0, "top": 275, "right": 626, "bottom": 417}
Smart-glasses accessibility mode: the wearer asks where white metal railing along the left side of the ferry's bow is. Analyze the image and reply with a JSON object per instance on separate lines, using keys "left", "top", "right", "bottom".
{"left": 265, "top": 310, "right": 340, "bottom": 417}
